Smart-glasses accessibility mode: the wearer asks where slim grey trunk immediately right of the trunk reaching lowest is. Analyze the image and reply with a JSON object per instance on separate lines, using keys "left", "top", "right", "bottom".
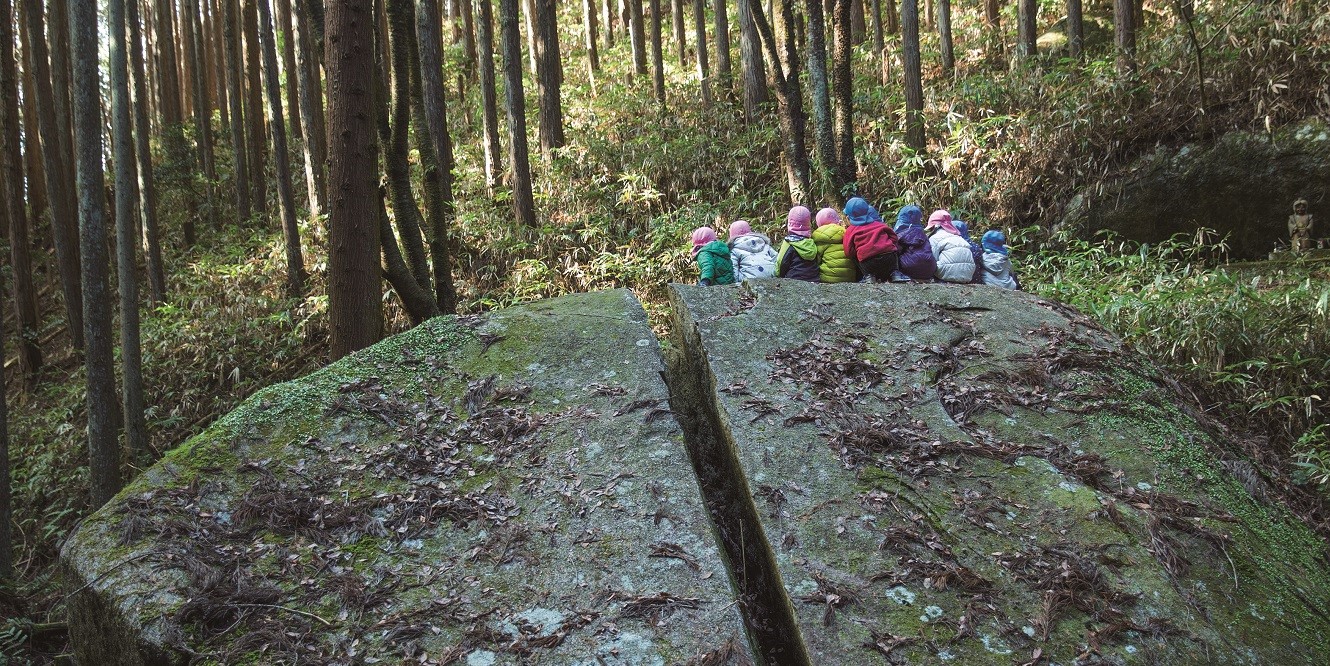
{"left": 106, "top": 0, "right": 145, "bottom": 459}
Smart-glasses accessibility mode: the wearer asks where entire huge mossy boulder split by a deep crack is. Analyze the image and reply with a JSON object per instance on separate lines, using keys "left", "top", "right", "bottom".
{"left": 63, "top": 280, "right": 1330, "bottom": 666}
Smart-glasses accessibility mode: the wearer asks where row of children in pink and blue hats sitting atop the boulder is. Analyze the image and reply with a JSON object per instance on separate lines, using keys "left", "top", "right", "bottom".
{"left": 693, "top": 197, "right": 1020, "bottom": 290}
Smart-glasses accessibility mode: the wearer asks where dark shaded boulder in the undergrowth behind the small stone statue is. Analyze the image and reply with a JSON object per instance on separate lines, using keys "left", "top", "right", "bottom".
{"left": 1061, "top": 121, "right": 1330, "bottom": 259}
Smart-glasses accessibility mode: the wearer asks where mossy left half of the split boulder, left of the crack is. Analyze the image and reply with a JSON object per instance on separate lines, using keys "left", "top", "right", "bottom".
{"left": 63, "top": 291, "right": 750, "bottom": 666}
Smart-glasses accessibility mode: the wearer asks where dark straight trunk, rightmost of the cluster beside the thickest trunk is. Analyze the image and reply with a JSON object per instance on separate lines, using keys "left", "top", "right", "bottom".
{"left": 412, "top": 0, "right": 458, "bottom": 315}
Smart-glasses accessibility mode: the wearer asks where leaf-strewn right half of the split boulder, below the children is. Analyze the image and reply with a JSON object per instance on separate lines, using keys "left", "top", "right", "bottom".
{"left": 672, "top": 280, "right": 1330, "bottom": 666}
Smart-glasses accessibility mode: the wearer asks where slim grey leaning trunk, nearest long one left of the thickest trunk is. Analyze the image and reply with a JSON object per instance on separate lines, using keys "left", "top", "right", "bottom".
{"left": 254, "top": 0, "right": 305, "bottom": 298}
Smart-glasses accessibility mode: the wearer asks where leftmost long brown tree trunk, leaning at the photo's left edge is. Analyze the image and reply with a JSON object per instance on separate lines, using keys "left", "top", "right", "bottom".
{"left": 0, "top": 0, "right": 41, "bottom": 382}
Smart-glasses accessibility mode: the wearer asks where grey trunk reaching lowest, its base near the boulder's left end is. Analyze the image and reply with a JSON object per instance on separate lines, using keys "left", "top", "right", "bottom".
{"left": 69, "top": 0, "right": 120, "bottom": 506}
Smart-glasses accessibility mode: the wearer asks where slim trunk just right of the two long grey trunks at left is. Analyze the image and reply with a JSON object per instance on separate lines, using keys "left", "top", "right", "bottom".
{"left": 125, "top": 0, "right": 166, "bottom": 304}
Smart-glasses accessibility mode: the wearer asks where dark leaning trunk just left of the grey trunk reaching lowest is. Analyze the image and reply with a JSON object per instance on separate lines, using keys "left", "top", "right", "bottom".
{"left": 23, "top": 0, "right": 84, "bottom": 351}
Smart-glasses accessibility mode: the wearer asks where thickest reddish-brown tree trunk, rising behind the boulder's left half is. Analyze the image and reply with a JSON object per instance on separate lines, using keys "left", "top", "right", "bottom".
{"left": 325, "top": 0, "right": 391, "bottom": 359}
